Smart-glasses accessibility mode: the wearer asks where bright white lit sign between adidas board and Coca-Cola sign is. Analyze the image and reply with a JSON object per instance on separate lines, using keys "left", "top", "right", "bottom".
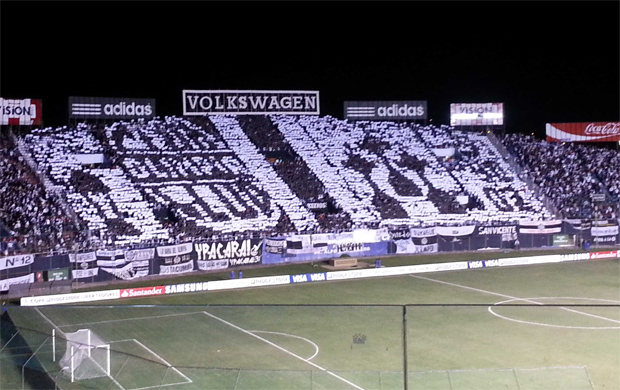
{"left": 450, "top": 103, "right": 504, "bottom": 126}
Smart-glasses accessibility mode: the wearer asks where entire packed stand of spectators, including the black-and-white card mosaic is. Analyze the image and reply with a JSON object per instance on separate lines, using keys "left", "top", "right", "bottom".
{"left": 13, "top": 115, "right": 620, "bottom": 254}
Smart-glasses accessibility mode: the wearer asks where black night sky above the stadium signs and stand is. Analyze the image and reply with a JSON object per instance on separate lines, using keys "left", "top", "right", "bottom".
{"left": 0, "top": 1, "right": 620, "bottom": 139}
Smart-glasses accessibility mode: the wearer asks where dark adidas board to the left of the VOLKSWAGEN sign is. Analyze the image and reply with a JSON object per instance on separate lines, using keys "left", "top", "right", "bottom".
{"left": 69, "top": 96, "right": 155, "bottom": 119}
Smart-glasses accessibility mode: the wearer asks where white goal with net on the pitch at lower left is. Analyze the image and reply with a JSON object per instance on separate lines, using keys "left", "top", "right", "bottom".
{"left": 59, "top": 329, "right": 110, "bottom": 382}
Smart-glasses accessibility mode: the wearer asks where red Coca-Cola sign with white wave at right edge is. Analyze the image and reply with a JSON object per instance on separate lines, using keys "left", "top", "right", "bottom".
{"left": 547, "top": 122, "right": 620, "bottom": 142}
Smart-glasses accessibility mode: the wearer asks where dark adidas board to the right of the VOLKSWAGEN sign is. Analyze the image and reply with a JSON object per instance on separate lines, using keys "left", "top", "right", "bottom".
{"left": 344, "top": 100, "right": 427, "bottom": 121}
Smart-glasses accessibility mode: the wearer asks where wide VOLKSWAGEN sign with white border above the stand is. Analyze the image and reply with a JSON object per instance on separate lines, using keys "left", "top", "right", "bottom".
{"left": 183, "top": 90, "right": 320, "bottom": 115}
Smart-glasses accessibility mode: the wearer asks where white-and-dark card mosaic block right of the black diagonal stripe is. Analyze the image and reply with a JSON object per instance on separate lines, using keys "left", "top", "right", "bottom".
{"left": 274, "top": 116, "right": 550, "bottom": 226}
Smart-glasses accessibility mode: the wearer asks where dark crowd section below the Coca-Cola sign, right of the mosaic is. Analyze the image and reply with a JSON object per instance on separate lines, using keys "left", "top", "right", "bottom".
{"left": 502, "top": 134, "right": 620, "bottom": 219}
